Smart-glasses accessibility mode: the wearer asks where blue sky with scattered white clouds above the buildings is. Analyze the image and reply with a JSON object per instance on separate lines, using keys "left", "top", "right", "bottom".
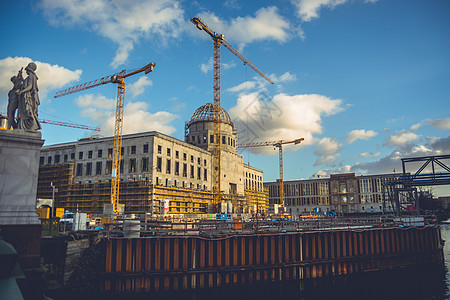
{"left": 0, "top": 0, "right": 450, "bottom": 196}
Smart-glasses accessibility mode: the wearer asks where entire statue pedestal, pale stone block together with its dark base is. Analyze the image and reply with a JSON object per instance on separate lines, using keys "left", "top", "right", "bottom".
{"left": 0, "top": 130, "right": 44, "bottom": 269}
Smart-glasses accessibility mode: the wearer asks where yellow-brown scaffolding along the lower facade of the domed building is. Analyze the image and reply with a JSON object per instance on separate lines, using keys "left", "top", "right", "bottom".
{"left": 38, "top": 162, "right": 269, "bottom": 215}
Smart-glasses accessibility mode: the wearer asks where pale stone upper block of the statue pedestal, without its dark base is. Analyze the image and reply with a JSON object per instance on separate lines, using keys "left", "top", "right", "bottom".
{"left": 0, "top": 130, "right": 44, "bottom": 225}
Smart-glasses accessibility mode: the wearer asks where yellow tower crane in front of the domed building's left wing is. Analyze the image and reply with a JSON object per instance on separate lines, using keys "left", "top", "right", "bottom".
{"left": 54, "top": 62, "right": 155, "bottom": 216}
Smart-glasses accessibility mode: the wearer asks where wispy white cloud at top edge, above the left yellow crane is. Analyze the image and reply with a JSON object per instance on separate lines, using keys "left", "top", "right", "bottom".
{"left": 41, "top": 0, "right": 185, "bottom": 68}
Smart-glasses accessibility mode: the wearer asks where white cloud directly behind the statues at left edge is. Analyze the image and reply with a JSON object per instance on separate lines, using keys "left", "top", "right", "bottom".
{"left": 0, "top": 57, "right": 82, "bottom": 107}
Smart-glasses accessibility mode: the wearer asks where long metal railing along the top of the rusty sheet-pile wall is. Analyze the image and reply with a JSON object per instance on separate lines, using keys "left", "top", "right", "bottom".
{"left": 94, "top": 216, "right": 438, "bottom": 237}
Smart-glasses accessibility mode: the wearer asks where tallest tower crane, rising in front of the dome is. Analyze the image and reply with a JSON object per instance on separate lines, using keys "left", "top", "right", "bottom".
{"left": 191, "top": 17, "right": 273, "bottom": 212}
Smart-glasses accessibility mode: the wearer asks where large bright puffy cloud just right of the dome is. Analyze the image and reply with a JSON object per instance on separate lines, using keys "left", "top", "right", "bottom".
{"left": 229, "top": 93, "right": 342, "bottom": 154}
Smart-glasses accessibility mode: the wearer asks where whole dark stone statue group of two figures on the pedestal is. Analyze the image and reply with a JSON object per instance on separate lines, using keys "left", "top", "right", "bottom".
{"left": 7, "top": 62, "right": 41, "bottom": 131}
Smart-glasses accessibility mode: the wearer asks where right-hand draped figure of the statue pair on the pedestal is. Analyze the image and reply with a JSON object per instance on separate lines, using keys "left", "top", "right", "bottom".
{"left": 17, "top": 62, "right": 41, "bottom": 131}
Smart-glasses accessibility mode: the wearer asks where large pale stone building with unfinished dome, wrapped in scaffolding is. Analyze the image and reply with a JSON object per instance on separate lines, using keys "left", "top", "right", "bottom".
{"left": 38, "top": 104, "right": 269, "bottom": 214}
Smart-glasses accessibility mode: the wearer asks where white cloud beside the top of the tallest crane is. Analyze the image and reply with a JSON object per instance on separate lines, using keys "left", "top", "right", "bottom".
{"left": 199, "top": 6, "right": 291, "bottom": 44}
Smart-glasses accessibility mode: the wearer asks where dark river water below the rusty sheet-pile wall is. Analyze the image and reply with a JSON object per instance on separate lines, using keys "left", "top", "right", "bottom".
{"left": 184, "top": 224, "right": 450, "bottom": 300}
